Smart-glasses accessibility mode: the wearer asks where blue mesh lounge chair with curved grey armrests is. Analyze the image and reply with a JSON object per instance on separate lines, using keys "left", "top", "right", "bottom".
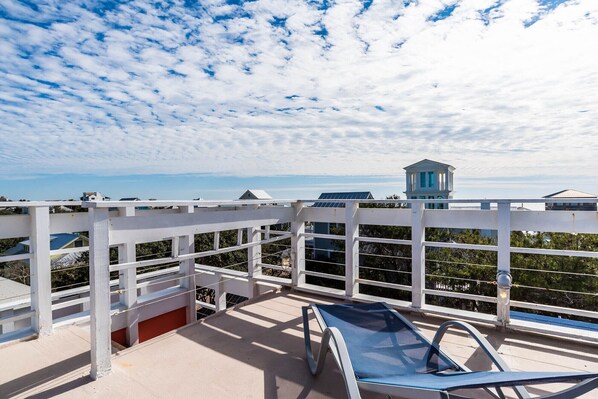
{"left": 303, "top": 303, "right": 598, "bottom": 399}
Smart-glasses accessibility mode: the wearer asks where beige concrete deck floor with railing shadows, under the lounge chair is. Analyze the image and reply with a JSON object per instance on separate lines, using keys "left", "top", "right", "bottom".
{"left": 0, "top": 290, "right": 598, "bottom": 399}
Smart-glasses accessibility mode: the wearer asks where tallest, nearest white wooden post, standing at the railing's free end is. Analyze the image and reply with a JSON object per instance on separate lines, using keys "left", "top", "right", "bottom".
{"left": 89, "top": 208, "right": 112, "bottom": 380}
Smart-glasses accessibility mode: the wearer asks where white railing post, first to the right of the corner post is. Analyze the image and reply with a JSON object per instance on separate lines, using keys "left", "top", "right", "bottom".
{"left": 345, "top": 202, "right": 359, "bottom": 297}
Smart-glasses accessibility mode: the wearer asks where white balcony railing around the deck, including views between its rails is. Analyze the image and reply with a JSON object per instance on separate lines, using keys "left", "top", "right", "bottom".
{"left": 0, "top": 200, "right": 598, "bottom": 378}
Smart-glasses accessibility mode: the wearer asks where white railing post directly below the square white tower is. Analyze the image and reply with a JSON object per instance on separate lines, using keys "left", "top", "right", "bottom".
{"left": 411, "top": 202, "right": 426, "bottom": 308}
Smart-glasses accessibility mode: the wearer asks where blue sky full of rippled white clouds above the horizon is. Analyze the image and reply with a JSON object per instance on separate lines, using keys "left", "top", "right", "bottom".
{"left": 0, "top": 0, "right": 598, "bottom": 200}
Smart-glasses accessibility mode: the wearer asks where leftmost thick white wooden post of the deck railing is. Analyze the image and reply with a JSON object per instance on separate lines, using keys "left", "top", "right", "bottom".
{"left": 29, "top": 206, "right": 52, "bottom": 337}
